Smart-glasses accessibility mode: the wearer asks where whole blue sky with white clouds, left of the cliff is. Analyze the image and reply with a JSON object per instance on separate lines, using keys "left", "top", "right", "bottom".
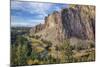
{"left": 11, "top": 1, "right": 68, "bottom": 26}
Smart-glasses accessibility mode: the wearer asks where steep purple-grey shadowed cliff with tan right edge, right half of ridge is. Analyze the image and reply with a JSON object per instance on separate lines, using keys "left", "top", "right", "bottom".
{"left": 61, "top": 6, "right": 95, "bottom": 40}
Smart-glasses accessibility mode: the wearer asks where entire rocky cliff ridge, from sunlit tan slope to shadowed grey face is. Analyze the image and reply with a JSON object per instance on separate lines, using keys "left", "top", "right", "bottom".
{"left": 30, "top": 5, "right": 95, "bottom": 44}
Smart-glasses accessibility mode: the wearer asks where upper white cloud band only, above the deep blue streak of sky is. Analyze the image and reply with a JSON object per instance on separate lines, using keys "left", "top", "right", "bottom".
{"left": 11, "top": 1, "right": 52, "bottom": 16}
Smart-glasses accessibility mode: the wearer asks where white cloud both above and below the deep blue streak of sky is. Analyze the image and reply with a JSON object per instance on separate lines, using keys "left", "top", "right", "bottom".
{"left": 11, "top": 1, "right": 52, "bottom": 26}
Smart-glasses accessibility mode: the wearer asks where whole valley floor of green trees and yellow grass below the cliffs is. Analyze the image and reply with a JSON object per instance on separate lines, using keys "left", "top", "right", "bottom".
{"left": 11, "top": 26, "right": 95, "bottom": 66}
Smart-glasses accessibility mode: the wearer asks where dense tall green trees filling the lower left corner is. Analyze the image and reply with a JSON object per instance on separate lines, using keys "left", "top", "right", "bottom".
{"left": 11, "top": 36, "right": 30, "bottom": 65}
